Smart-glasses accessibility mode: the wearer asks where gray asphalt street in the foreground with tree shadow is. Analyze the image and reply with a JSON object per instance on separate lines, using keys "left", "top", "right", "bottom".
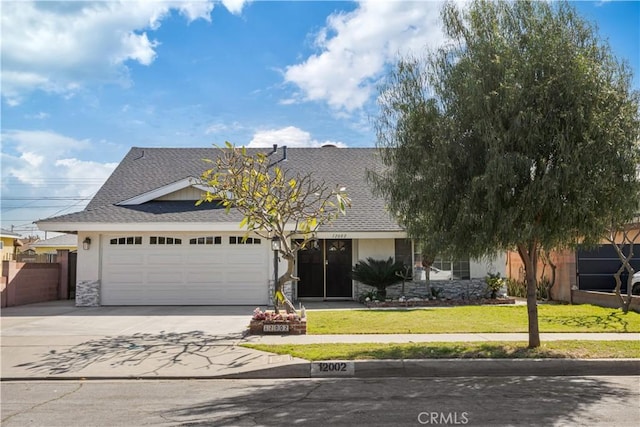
{"left": 0, "top": 376, "right": 640, "bottom": 427}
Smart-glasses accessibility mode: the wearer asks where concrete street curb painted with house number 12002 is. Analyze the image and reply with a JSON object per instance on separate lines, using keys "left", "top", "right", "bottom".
{"left": 0, "top": 359, "right": 640, "bottom": 382}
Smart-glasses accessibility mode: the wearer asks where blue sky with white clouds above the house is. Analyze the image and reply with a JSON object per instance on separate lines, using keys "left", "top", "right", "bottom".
{"left": 0, "top": 0, "right": 640, "bottom": 236}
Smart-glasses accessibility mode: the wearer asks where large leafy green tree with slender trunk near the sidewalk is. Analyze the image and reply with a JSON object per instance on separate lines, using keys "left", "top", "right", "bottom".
{"left": 370, "top": 1, "right": 640, "bottom": 347}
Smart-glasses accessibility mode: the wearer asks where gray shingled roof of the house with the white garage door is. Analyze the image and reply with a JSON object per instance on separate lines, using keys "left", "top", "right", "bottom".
{"left": 38, "top": 147, "right": 402, "bottom": 232}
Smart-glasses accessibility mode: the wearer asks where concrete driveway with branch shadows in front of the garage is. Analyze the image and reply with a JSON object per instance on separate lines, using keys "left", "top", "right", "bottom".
{"left": 1, "top": 301, "right": 304, "bottom": 380}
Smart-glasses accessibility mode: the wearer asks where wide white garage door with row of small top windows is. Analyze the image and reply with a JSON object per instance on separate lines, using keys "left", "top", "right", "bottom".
{"left": 101, "top": 234, "right": 270, "bottom": 305}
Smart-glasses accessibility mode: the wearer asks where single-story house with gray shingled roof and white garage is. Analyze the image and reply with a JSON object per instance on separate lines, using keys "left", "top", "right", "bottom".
{"left": 37, "top": 147, "right": 504, "bottom": 305}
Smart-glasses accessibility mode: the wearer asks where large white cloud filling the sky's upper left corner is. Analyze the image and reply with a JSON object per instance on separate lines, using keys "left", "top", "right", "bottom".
{"left": 0, "top": 0, "right": 218, "bottom": 105}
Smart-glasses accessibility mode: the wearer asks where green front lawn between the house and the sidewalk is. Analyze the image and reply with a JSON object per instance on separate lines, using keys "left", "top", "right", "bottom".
{"left": 307, "top": 304, "right": 640, "bottom": 334}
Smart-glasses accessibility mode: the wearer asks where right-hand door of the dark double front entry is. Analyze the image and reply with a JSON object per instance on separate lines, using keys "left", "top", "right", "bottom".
{"left": 325, "top": 240, "right": 353, "bottom": 298}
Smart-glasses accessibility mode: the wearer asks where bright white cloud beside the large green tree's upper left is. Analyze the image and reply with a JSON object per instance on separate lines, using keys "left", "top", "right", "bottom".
{"left": 284, "top": 1, "right": 444, "bottom": 112}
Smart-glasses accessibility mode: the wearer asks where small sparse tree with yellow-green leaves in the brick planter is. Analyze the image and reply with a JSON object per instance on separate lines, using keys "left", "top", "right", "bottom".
{"left": 198, "top": 142, "right": 351, "bottom": 313}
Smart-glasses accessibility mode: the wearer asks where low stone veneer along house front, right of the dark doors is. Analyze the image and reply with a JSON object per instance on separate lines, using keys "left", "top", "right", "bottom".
{"left": 356, "top": 279, "right": 507, "bottom": 299}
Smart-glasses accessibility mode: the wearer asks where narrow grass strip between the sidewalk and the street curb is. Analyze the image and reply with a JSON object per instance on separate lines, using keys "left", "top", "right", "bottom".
{"left": 242, "top": 341, "right": 640, "bottom": 361}
